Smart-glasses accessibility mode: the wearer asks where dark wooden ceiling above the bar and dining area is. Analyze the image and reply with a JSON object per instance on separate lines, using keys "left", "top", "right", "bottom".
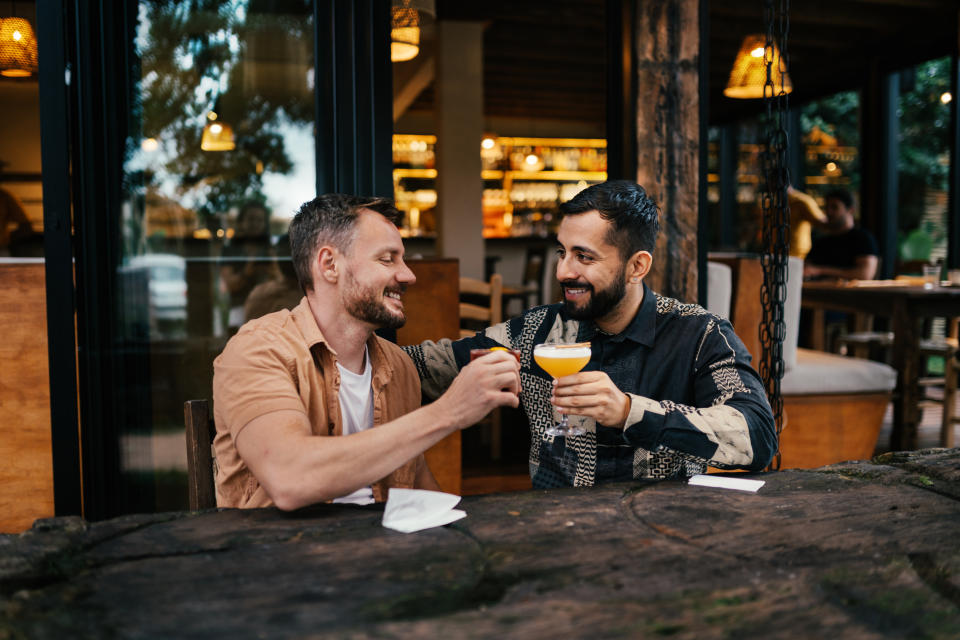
{"left": 402, "top": 0, "right": 960, "bottom": 129}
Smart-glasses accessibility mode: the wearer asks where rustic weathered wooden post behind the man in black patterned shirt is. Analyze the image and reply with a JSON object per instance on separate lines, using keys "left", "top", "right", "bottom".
{"left": 636, "top": 0, "right": 700, "bottom": 302}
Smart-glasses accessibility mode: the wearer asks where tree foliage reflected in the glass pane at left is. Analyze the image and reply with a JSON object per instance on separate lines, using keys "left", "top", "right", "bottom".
{"left": 130, "top": 0, "right": 313, "bottom": 226}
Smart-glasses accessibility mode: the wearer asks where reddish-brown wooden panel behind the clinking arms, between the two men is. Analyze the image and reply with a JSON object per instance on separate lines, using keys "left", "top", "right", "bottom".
{"left": 397, "top": 258, "right": 463, "bottom": 495}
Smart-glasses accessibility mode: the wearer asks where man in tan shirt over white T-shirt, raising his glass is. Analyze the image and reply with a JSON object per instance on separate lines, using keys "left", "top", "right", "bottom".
{"left": 213, "top": 194, "right": 519, "bottom": 510}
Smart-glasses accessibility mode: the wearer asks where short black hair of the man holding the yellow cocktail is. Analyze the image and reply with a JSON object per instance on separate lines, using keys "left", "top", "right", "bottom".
{"left": 560, "top": 180, "right": 660, "bottom": 260}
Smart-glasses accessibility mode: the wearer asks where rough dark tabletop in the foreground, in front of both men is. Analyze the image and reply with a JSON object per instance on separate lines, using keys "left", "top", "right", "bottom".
{"left": 0, "top": 449, "right": 960, "bottom": 639}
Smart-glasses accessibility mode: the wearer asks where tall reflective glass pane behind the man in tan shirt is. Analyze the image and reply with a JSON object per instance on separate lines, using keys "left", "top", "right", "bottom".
{"left": 118, "top": 0, "right": 316, "bottom": 511}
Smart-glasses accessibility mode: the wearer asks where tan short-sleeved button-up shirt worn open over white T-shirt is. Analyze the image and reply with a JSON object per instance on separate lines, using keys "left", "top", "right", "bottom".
{"left": 213, "top": 298, "right": 425, "bottom": 508}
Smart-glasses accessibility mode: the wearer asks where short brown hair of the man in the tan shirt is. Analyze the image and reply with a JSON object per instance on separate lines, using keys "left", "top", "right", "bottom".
{"left": 289, "top": 193, "right": 403, "bottom": 291}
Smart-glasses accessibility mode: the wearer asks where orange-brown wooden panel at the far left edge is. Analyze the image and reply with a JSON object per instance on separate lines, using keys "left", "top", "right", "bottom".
{"left": 0, "top": 262, "right": 54, "bottom": 533}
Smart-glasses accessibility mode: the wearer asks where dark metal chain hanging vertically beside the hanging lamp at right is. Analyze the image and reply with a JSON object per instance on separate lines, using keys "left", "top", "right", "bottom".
{"left": 760, "top": 0, "right": 799, "bottom": 469}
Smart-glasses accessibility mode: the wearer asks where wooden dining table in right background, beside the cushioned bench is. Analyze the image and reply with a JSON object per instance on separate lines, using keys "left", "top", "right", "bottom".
{"left": 801, "top": 280, "right": 960, "bottom": 449}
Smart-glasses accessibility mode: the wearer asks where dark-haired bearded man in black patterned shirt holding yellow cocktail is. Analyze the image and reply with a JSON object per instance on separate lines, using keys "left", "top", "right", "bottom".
{"left": 404, "top": 181, "right": 777, "bottom": 488}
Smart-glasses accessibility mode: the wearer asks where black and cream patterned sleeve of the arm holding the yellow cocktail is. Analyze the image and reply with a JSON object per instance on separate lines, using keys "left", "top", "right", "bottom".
{"left": 623, "top": 317, "right": 777, "bottom": 471}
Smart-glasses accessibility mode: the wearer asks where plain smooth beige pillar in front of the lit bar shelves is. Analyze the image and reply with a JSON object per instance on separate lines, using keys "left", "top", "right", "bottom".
{"left": 435, "top": 20, "right": 484, "bottom": 278}
